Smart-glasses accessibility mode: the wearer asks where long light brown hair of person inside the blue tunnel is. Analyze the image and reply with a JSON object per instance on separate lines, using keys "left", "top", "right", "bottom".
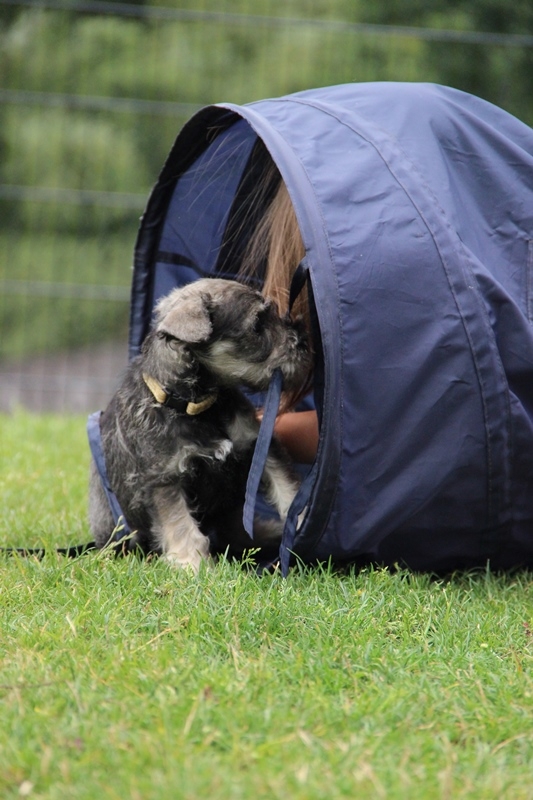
{"left": 240, "top": 162, "right": 312, "bottom": 411}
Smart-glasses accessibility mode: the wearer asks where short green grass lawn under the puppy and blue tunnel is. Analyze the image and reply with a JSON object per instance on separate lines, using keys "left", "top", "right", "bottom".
{"left": 0, "top": 413, "right": 533, "bottom": 800}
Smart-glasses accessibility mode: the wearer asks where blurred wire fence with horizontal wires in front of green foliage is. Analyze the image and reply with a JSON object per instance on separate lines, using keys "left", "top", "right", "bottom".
{"left": 0, "top": 0, "right": 533, "bottom": 411}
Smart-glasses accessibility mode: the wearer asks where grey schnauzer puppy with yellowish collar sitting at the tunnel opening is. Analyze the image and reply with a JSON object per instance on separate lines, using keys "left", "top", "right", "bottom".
{"left": 89, "top": 278, "right": 310, "bottom": 570}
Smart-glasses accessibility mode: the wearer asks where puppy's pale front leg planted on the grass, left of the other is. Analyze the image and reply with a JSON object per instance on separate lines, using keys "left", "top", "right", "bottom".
{"left": 154, "top": 487, "right": 209, "bottom": 572}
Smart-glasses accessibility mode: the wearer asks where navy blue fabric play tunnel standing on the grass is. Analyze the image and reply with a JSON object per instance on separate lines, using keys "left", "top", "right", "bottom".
{"left": 130, "top": 83, "right": 533, "bottom": 571}
